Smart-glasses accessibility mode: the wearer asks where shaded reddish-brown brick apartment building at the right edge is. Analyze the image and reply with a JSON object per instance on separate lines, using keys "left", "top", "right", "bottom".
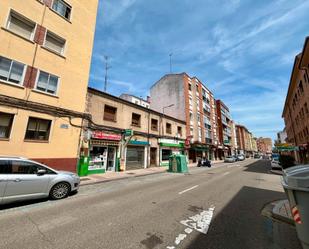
{"left": 282, "top": 37, "right": 309, "bottom": 163}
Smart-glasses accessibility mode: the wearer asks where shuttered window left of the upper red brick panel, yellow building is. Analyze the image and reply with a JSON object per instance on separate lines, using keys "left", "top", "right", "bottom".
{"left": 7, "top": 11, "right": 35, "bottom": 40}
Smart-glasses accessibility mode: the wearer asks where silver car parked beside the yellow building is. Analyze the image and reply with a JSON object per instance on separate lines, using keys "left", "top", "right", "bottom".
{"left": 0, "top": 156, "right": 80, "bottom": 204}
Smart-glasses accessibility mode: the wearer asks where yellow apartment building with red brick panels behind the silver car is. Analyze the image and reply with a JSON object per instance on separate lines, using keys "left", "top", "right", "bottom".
{"left": 0, "top": 0, "right": 98, "bottom": 171}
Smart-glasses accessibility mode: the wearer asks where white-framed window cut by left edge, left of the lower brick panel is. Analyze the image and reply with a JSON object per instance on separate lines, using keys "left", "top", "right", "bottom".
{"left": 0, "top": 56, "right": 25, "bottom": 84}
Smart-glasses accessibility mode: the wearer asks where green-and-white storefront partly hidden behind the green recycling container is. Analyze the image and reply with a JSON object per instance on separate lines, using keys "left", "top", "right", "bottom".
{"left": 158, "top": 139, "right": 185, "bottom": 166}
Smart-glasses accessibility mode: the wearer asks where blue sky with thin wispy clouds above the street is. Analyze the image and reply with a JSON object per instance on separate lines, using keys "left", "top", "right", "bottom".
{"left": 89, "top": 0, "right": 309, "bottom": 138}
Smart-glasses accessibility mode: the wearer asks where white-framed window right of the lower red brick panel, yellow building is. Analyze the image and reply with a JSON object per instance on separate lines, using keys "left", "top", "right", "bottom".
{"left": 36, "top": 71, "right": 59, "bottom": 95}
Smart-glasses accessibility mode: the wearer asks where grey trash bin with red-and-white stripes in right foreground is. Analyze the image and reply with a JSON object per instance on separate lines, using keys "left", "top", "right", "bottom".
{"left": 282, "top": 165, "right": 309, "bottom": 249}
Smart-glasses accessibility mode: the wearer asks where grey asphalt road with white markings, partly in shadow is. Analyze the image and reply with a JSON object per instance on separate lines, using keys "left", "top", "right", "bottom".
{"left": 0, "top": 159, "right": 301, "bottom": 249}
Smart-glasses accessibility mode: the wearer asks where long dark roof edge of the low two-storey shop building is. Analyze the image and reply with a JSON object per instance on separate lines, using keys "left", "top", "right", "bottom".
{"left": 88, "top": 87, "right": 186, "bottom": 124}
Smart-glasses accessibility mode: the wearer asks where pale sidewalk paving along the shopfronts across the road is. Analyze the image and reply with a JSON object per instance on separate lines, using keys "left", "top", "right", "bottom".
{"left": 80, "top": 160, "right": 223, "bottom": 186}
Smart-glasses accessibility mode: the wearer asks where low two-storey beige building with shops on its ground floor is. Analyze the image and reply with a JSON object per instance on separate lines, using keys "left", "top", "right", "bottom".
{"left": 84, "top": 88, "right": 186, "bottom": 174}
